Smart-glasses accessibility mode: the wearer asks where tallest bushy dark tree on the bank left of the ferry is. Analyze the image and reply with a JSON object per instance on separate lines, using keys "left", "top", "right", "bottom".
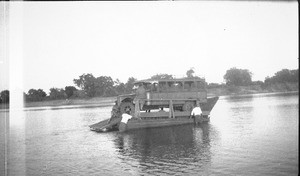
{"left": 73, "top": 73, "right": 96, "bottom": 97}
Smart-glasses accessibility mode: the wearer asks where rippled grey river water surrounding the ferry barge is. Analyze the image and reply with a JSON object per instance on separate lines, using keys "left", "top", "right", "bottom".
{"left": 0, "top": 93, "right": 299, "bottom": 176}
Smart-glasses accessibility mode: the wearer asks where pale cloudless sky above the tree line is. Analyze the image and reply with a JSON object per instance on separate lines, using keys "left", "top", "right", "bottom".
{"left": 0, "top": 1, "right": 299, "bottom": 93}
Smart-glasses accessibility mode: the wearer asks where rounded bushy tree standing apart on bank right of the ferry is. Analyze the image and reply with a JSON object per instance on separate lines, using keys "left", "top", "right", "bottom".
{"left": 223, "top": 67, "right": 252, "bottom": 86}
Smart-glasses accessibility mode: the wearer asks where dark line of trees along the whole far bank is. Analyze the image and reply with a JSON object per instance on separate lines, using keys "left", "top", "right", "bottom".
{"left": 0, "top": 67, "right": 299, "bottom": 103}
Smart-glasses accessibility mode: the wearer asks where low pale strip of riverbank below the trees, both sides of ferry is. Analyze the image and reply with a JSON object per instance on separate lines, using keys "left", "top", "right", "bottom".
{"left": 0, "top": 83, "right": 299, "bottom": 109}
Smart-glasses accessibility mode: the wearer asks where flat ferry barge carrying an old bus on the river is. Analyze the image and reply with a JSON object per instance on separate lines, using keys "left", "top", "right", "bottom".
{"left": 90, "top": 77, "right": 219, "bottom": 132}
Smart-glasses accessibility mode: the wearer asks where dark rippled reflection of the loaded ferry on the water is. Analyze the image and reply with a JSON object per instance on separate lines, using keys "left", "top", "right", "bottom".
{"left": 114, "top": 124, "right": 211, "bottom": 175}
